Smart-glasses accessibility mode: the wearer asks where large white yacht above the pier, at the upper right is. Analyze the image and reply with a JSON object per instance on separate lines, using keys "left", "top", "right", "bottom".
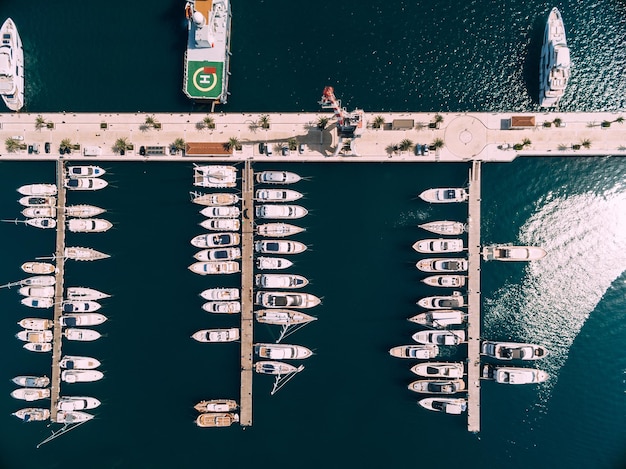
{"left": 539, "top": 8, "right": 570, "bottom": 107}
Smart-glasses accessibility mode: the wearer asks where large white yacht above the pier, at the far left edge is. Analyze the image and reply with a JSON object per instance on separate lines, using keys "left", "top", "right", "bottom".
{"left": 0, "top": 18, "right": 24, "bottom": 111}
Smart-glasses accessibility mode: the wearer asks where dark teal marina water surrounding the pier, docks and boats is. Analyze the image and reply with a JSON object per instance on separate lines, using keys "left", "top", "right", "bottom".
{"left": 0, "top": 0, "right": 626, "bottom": 468}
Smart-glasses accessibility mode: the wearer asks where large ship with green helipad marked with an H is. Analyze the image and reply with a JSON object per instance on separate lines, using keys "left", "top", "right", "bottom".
{"left": 183, "top": 0, "right": 231, "bottom": 104}
